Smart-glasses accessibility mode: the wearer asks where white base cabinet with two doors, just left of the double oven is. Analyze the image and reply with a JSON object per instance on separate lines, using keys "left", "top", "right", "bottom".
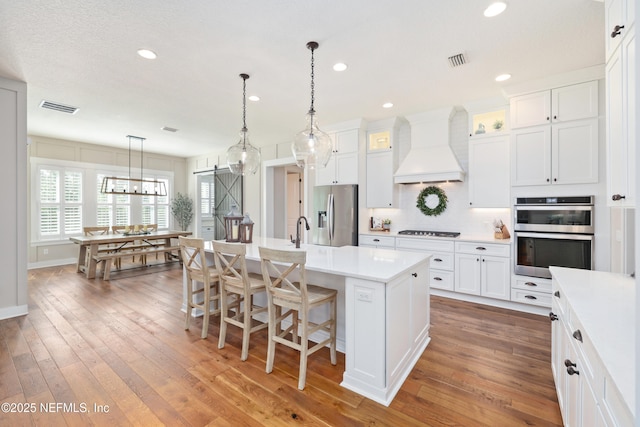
{"left": 455, "top": 242, "right": 511, "bottom": 300}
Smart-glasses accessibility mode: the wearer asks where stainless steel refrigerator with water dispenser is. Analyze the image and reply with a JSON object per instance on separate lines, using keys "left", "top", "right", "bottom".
{"left": 312, "top": 185, "right": 358, "bottom": 246}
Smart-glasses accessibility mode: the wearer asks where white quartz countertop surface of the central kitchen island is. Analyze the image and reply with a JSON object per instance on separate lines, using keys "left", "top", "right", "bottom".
{"left": 205, "top": 236, "right": 431, "bottom": 283}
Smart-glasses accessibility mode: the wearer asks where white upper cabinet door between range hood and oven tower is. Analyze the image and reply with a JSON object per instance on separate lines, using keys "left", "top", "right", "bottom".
{"left": 469, "top": 135, "right": 511, "bottom": 208}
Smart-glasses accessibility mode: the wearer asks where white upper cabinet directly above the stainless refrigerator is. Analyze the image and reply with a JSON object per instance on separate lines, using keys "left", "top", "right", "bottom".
{"left": 316, "top": 129, "right": 359, "bottom": 185}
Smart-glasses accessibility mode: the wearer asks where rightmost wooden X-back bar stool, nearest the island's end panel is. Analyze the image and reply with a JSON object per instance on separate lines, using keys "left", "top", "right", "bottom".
{"left": 258, "top": 247, "right": 337, "bottom": 390}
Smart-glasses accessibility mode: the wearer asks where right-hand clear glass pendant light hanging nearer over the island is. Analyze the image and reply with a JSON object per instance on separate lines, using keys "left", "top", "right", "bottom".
{"left": 291, "top": 42, "right": 332, "bottom": 169}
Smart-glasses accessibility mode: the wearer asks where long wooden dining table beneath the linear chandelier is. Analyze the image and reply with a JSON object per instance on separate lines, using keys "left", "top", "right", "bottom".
{"left": 69, "top": 230, "right": 191, "bottom": 279}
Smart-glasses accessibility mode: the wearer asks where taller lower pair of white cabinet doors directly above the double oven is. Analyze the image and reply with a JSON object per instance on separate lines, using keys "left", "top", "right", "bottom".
{"left": 511, "top": 119, "right": 598, "bottom": 186}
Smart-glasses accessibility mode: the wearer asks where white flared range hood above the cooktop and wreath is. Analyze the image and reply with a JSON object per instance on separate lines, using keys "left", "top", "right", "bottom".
{"left": 393, "top": 108, "right": 464, "bottom": 184}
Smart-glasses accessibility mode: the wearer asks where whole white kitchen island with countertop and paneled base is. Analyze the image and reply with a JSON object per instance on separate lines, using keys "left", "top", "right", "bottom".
{"left": 185, "top": 237, "right": 431, "bottom": 406}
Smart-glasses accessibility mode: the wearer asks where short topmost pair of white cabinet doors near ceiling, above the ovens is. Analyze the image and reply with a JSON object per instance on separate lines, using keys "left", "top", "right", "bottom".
{"left": 510, "top": 80, "right": 598, "bottom": 129}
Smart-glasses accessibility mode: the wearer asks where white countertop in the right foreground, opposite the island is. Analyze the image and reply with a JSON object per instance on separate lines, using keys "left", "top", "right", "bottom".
{"left": 550, "top": 267, "right": 636, "bottom": 414}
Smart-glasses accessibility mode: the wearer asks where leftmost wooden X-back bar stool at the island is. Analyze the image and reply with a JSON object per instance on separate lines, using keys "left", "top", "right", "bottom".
{"left": 178, "top": 236, "right": 220, "bottom": 338}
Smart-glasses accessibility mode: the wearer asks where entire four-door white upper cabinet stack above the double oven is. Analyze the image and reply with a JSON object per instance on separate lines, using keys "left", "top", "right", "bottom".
{"left": 510, "top": 81, "right": 599, "bottom": 186}
